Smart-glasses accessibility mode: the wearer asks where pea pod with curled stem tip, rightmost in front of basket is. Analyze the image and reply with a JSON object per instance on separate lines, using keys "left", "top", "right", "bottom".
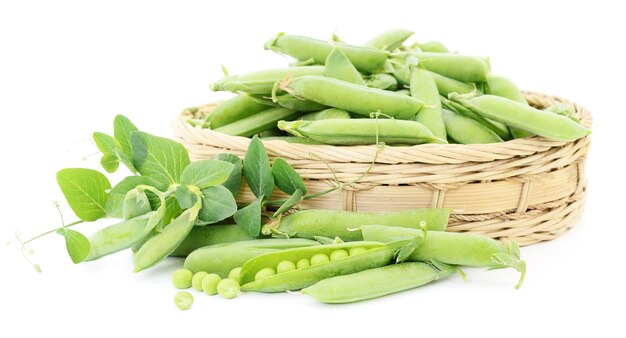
{"left": 361, "top": 225, "right": 526, "bottom": 288}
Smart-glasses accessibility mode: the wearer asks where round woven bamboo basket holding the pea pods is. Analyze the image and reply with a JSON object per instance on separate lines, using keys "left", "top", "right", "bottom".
{"left": 174, "top": 92, "right": 591, "bottom": 245}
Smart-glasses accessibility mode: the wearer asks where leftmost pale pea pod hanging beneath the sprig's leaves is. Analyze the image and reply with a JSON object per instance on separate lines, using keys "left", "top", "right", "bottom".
{"left": 85, "top": 211, "right": 154, "bottom": 261}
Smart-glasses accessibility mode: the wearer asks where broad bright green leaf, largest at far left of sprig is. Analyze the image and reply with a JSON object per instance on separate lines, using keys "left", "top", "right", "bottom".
{"left": 57, "top": 168, "right": 111, "bottom": 222}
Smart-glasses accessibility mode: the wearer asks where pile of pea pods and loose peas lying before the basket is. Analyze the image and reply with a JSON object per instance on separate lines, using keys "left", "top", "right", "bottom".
{"left": 172, "top": 208, "right": 526, "bottom": 309}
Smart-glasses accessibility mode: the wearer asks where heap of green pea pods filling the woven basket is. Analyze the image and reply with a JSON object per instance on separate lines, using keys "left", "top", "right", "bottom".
{"left": 184, "top": 29, "right": 590, "bottom": 145}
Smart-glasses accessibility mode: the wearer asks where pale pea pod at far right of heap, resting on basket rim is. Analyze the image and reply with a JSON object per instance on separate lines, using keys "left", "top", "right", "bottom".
{"left": 454, "top": 95, "right": 591, "bottom": 141}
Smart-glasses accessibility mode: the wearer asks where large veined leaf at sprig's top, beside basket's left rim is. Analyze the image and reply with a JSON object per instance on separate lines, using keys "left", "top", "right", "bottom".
{"left": 130, "top": 131, "right": 189, "bottom": 185}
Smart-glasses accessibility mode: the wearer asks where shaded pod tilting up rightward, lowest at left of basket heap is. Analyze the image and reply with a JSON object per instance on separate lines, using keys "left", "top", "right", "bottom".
{"left": 214, "top": 107, "right": 300, "bottom": 137}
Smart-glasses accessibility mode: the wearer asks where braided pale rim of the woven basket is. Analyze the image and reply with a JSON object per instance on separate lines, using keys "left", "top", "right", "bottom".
{"left": 173, "top": 91, "right": 592, "bottom": 164}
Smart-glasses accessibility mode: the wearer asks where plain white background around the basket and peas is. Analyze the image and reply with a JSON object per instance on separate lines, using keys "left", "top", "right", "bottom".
{"left": 0, "top": 1, "right": 626, "bottom": 337}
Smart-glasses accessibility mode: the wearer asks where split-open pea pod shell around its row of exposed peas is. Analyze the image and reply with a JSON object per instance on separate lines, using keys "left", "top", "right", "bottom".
{"left": 241, "top": 241, "right": 408, "bottom": 292}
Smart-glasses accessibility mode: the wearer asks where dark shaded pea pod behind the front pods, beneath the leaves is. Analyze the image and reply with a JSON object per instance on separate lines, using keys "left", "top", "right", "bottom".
{"left": 170, "top": 224, "right": 252, "bottom": 257}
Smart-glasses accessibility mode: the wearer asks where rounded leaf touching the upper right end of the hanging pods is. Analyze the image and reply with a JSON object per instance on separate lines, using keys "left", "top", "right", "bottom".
{"left": 199, "top": 185, "right": 237, "bottom": 223}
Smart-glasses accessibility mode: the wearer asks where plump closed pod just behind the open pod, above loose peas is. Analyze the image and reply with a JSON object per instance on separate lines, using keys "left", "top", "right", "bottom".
{"left": 184, "top": 238, "right": 319, "bottom": 278}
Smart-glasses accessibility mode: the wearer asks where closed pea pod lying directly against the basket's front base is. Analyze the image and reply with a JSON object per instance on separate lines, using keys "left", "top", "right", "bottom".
{"left": 263, "top": 208, "right": 451, "bottom": 241}
